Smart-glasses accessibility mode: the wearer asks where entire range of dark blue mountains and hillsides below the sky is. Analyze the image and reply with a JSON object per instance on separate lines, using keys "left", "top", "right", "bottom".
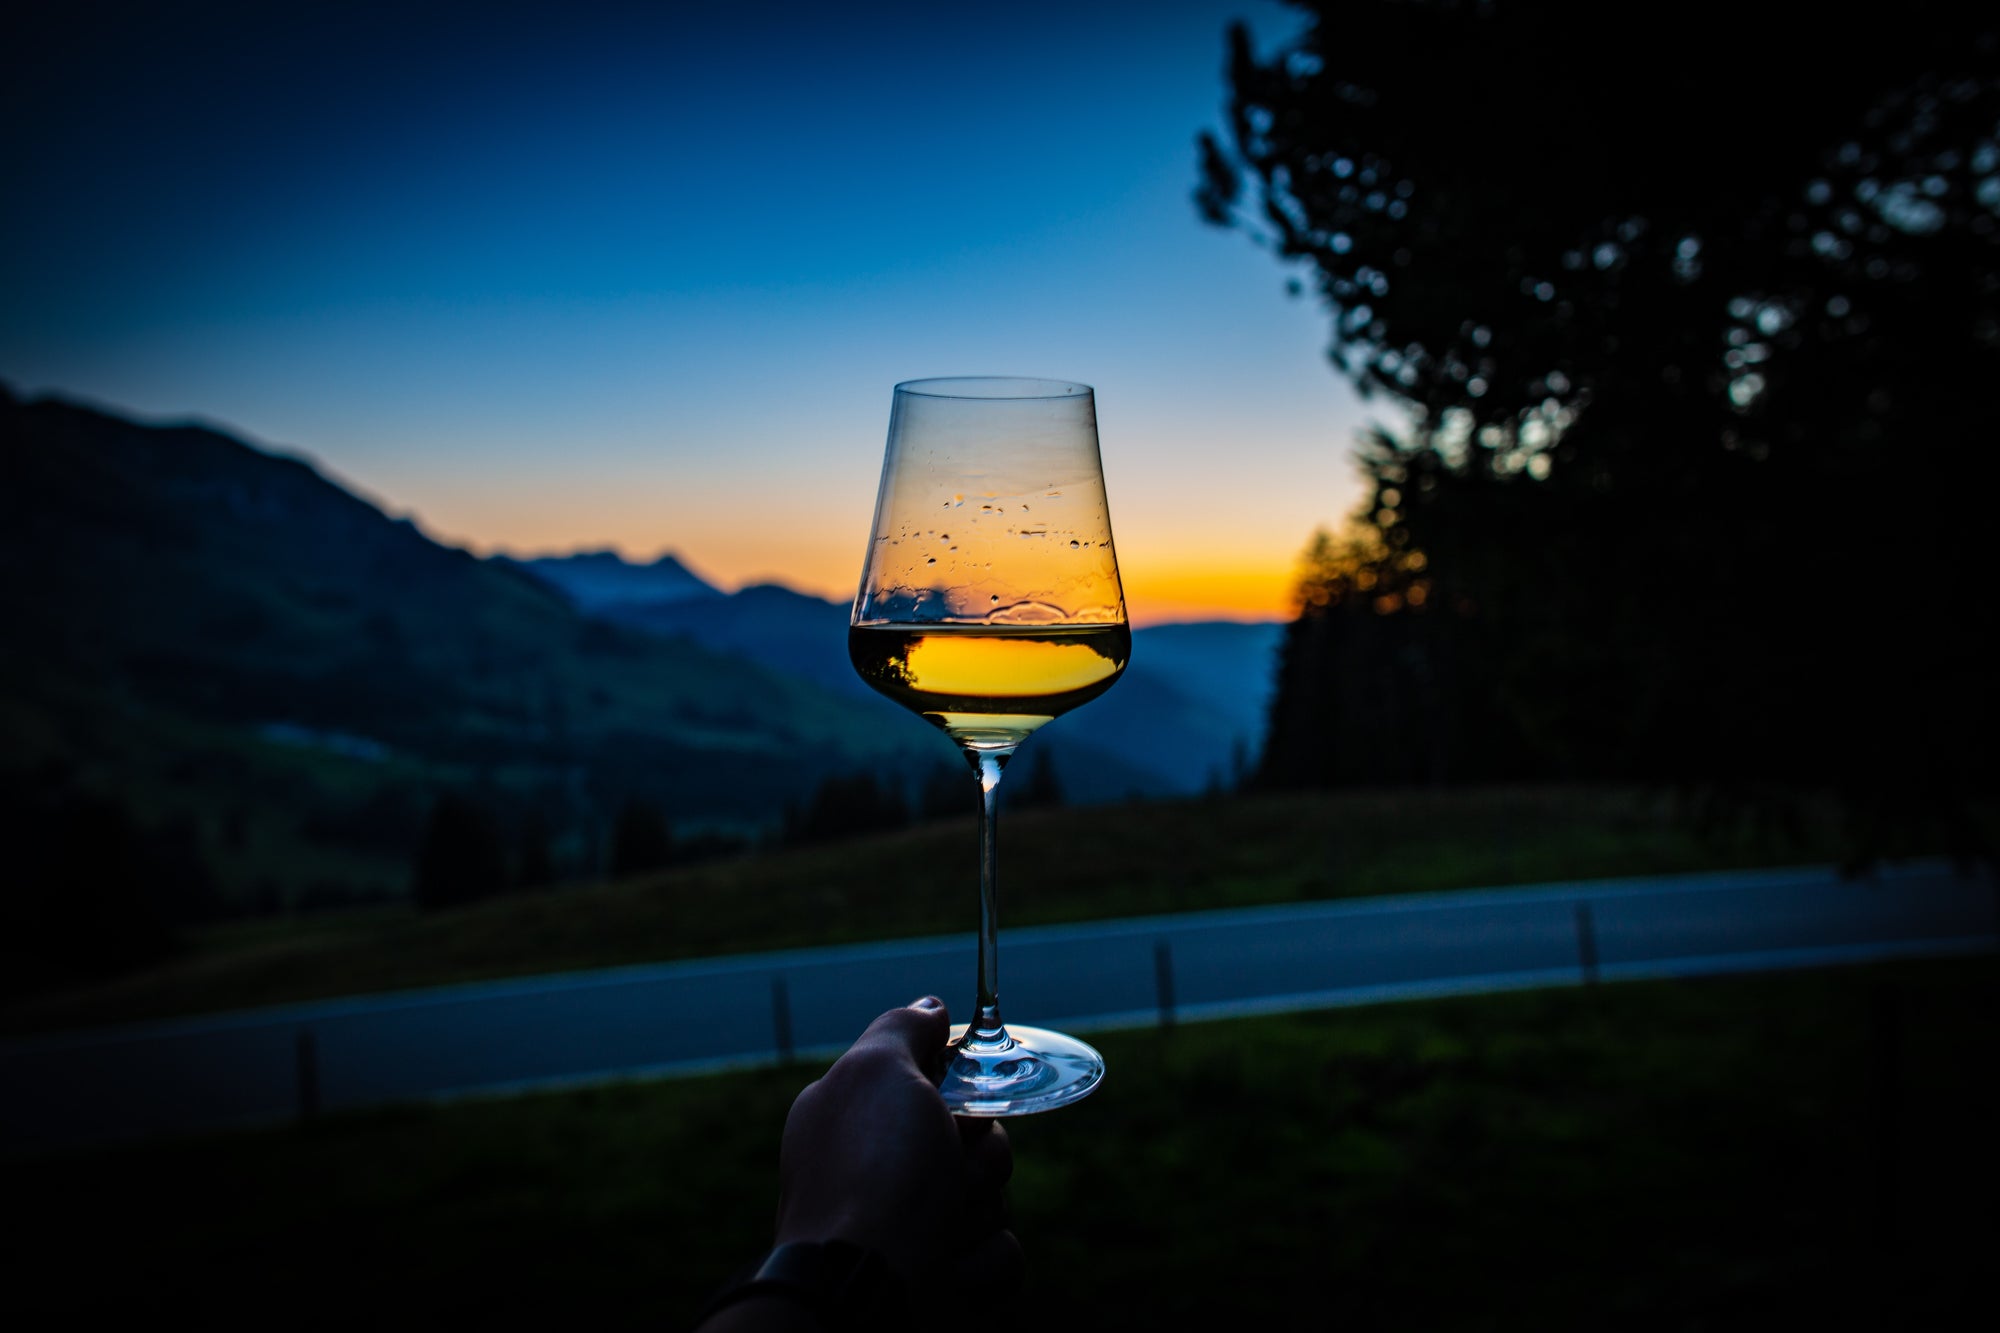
{"left": 0, "top": 388, "right": 1278, "bottom": 932}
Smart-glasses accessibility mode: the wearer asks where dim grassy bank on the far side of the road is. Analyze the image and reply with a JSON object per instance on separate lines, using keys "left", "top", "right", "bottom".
{"left": 0, "top": 787, "right": 1836, "bottom": 1033}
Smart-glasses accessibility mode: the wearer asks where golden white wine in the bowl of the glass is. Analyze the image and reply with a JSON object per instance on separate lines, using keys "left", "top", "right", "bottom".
{"left": 848, "top": 622, "right": 1132, "bottom": 747}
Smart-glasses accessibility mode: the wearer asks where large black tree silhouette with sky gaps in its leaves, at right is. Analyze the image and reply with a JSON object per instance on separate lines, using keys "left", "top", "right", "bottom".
{"left": 1196, "top": 0, "right": 2000, "bottom": 852}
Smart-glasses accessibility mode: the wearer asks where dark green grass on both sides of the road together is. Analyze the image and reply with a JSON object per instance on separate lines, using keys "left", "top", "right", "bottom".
{"left": 0, "top": 787, "right": 2000, "bottom": 1329}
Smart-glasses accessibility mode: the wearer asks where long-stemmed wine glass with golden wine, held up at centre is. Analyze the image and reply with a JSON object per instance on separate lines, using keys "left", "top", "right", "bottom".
{"left": 848, "top": 378, "right": 1132, "bottom": 1115}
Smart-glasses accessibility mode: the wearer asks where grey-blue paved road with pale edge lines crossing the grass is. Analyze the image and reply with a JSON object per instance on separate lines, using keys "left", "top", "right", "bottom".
{"left": 0, "top": 863, "right": 2000, "bottom": 1153}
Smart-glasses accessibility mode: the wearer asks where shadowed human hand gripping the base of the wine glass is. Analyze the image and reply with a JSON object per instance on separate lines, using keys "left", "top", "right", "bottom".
{"left": 776, "top": 997, "right": 1024, "bottom": 1301}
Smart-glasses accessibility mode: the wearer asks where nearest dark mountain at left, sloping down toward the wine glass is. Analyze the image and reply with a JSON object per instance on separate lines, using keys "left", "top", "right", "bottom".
{"left": 0, "top": 390, "right": 932, "bottom": 899}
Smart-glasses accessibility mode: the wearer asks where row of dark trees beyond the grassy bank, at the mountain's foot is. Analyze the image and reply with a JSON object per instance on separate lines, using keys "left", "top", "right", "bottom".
{"left": 0, "top": 753, "right": 1064, "bottom": 995}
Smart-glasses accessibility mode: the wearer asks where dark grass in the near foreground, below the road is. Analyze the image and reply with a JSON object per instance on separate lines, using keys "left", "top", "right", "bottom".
{"left": 0, "top": 959, "right": 2000, "bottom": 1331}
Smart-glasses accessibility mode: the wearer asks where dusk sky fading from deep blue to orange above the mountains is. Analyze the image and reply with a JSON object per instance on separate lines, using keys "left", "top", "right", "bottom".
{"left": 0, "top": 0, "right": 1370, "bottom": 622}
